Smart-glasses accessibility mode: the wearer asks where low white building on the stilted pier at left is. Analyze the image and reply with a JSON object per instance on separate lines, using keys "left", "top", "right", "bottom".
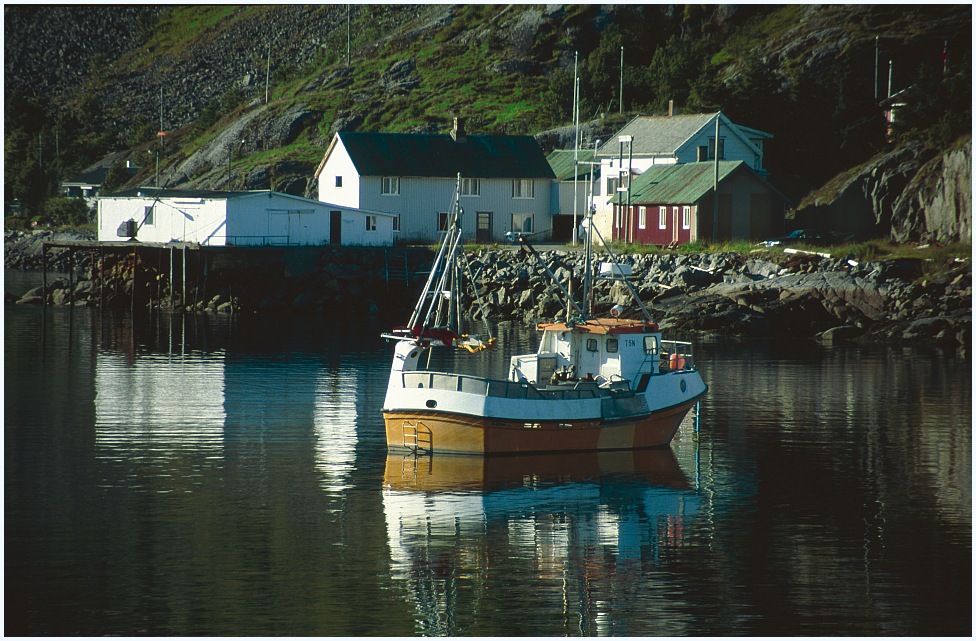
{"left": 98, "top": 187, "right": 393, "bottom": 247}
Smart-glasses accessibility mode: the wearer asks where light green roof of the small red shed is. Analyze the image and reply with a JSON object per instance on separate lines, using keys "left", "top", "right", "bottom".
{"left": 613, "top": 160, "right": 746, "bottom": 205}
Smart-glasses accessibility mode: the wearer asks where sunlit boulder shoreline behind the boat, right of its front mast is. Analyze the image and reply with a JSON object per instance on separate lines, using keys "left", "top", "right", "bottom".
{"left": 466, "top": 246, "right": 972, "bottom": 355}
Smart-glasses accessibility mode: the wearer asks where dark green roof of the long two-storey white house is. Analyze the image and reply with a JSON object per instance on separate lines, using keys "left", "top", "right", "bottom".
{"left": 338, "top": 132, "right": 555, "bottom": 179}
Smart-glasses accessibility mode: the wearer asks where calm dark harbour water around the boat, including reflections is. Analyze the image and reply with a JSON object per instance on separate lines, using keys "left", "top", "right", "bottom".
{"left": 4, "top": 270, "right": 972, "bottom": 636}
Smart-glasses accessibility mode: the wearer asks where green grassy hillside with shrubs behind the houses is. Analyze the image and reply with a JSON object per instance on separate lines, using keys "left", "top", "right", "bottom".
{"left": 4, "top": 5, "right": 971, "bottom": 245}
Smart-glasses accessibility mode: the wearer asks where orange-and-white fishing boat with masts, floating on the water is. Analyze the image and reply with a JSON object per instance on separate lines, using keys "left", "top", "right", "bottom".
{"left": 383, "top": 177, "right": 708, "bottom": 455}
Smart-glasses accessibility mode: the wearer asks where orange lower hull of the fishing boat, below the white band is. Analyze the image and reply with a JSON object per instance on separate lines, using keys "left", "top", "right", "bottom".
{"left": 383, "top": 399, "right": 698, "bottom": 454}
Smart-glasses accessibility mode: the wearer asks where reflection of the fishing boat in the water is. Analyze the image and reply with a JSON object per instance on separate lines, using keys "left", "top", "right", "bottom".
{"left": 383, "top": 448, "right": 700, "bottom": 635}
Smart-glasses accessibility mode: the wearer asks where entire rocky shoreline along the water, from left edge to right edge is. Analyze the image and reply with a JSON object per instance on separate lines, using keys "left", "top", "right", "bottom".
{"left": 4, "top": 233, "right": 972, "bottom": 356}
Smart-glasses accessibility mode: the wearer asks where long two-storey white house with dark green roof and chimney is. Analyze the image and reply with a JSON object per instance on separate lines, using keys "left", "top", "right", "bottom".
{"left": 315, "top": 118, "right": 555, "bottom": 242}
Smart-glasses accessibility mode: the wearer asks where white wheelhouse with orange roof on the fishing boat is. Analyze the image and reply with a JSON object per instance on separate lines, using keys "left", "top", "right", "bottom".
{"left": 509, "top": 318, "right": 693, "bottom": 391}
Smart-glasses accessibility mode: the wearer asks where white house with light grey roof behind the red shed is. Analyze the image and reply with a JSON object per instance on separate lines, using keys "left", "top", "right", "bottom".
{"left": 595, "top": 112, "right": 773, "bottom": 238}
